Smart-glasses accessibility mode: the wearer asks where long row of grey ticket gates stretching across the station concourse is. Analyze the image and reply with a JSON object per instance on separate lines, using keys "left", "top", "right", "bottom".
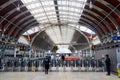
{"left": 4, "top": 58, "right": 105, "bottom": 72}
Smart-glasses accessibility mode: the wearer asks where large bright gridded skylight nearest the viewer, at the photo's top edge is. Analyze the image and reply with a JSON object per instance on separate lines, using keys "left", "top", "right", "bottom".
{"left": 22, "top": 0, "right": 87, "bottom": 24}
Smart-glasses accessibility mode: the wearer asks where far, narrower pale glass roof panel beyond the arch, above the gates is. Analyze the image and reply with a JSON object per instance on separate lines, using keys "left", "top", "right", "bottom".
{"left": 46, "top": 26, "right": 75, "bottom": 48}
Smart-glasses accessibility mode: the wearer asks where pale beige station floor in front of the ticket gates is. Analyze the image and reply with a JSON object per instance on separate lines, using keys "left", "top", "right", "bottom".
{"left": 0, "top": 72, "right": 120, "bottom": 80}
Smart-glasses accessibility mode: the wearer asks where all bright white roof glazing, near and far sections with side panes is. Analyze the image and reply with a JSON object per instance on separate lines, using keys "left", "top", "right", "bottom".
{"left": 22, "top": 0, "right": 95, "bottom": 48}
